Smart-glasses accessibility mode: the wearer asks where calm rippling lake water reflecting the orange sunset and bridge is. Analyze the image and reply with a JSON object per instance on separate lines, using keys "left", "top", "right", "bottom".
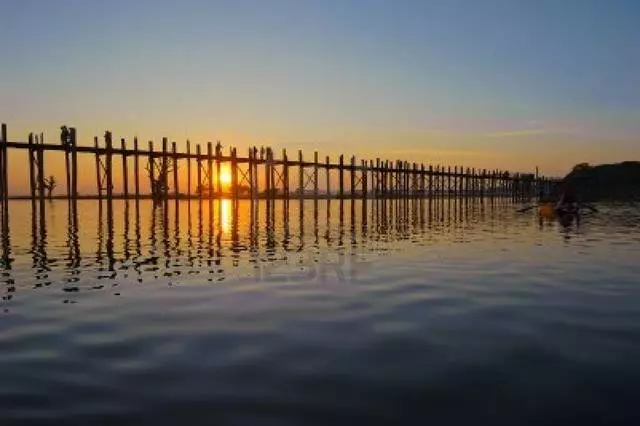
{"left": 0, "top": 201, "right": 640, "bottom": 425}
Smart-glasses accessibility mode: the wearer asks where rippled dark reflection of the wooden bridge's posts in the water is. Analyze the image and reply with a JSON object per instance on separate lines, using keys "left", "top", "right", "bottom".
{"left": 0, "top": 197, "right": 524, "bottom": 301}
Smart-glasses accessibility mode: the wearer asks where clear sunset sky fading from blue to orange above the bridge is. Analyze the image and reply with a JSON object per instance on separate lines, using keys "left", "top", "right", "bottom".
{"left": 0, "top": 0, "right": 640, "bottom": 194}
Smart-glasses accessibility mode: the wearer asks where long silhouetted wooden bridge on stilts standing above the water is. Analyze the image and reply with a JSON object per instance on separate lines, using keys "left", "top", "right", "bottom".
{"left": 0, "top": 124, "right": 549, "bottom": 211}
